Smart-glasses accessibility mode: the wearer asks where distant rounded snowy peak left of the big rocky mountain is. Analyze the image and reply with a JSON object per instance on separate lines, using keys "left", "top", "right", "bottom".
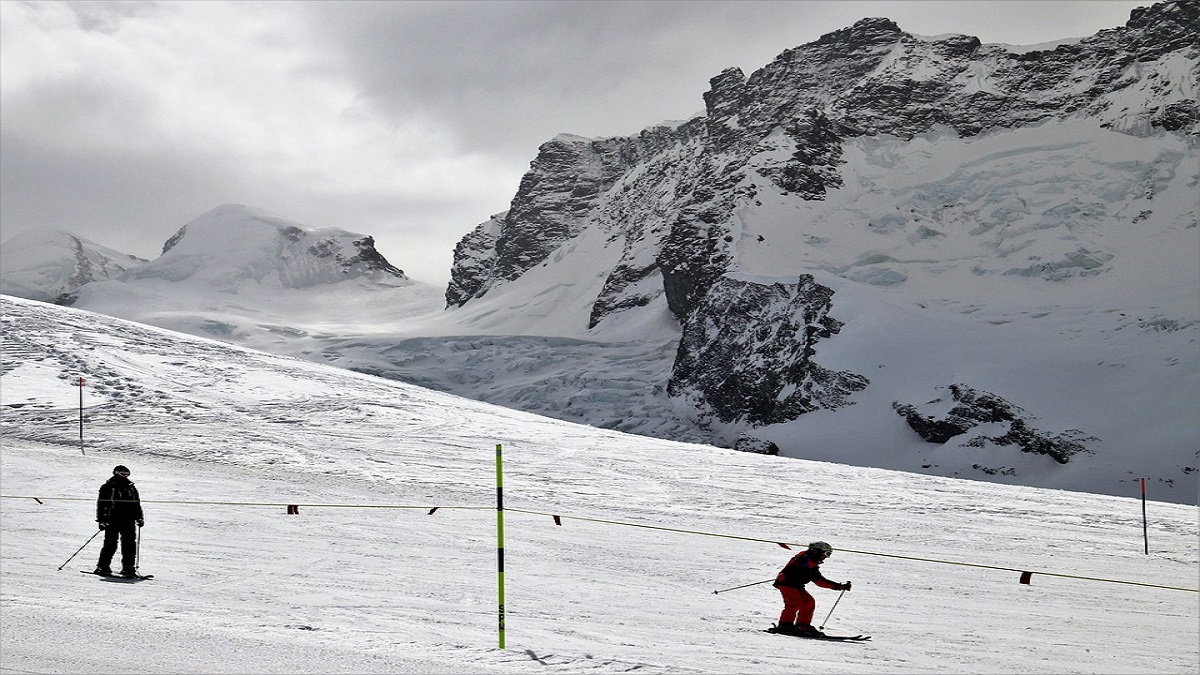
{"left": 0, "top": 204, "right": 451, "bottom": 347}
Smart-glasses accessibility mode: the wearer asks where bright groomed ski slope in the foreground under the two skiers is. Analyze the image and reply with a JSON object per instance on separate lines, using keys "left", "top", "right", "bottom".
{"left": 0, "top": 298, "right": 1200, "bottom": 673}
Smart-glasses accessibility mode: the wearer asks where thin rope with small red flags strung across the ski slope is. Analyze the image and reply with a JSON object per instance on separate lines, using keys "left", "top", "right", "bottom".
{"left": 0, "top": 495, "right": 1200, "bottom": 593}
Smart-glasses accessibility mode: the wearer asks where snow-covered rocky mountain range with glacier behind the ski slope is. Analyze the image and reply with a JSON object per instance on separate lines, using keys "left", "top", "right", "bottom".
{"left": 5, "top": 1, "right": 1200, "bottom": 502}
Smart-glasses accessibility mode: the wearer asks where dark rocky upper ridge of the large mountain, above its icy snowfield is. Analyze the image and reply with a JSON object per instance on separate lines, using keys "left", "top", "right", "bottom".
{"left": 446, "top": 1, "right": 1200, "bottom": 317}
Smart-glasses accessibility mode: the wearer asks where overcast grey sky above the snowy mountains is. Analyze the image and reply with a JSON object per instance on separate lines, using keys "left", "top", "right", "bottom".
{"left": 0, "top": 0, "right": 1151, "bottom": 285}
